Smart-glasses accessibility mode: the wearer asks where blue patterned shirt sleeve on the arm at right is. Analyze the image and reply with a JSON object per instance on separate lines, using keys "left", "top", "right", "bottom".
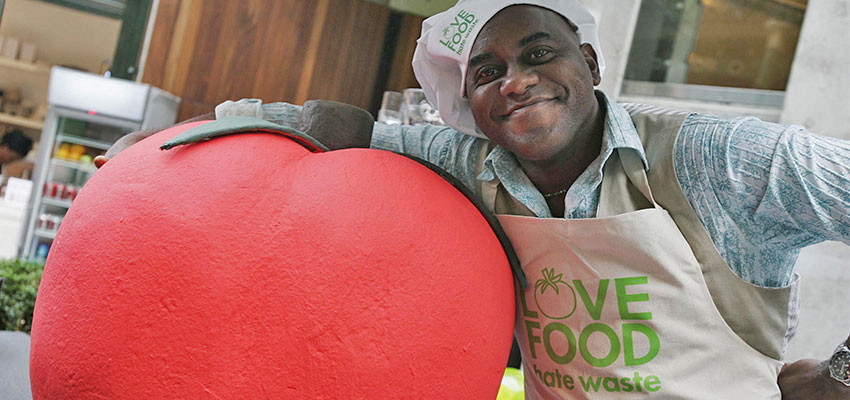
{"left": 675, "top": 115, "right": 850, "bottom": 287}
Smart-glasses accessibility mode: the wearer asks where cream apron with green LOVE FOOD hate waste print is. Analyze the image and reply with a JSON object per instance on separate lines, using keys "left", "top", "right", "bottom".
{"left": 482, "top": 150, "right": 782, "bottom": 399}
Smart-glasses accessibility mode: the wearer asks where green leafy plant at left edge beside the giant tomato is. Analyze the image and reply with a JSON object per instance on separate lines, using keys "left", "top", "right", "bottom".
{"left": 0, "top": 259, "right": 44, "bottom": 333}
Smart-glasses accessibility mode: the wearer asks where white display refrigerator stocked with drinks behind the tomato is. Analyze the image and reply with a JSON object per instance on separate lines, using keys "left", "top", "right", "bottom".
{"left": 19, "top": 66, "right": 180, "bottom": 261}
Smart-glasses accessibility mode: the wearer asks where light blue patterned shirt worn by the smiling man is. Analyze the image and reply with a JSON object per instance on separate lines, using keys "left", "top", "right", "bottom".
{"left": 224, "top": 92, "right": 850, "bottom": 287}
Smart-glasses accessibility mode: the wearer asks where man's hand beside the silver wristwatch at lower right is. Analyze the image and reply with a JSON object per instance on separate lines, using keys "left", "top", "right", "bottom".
{"left": 779, "top": 359, "right": 850, "bottom": 400}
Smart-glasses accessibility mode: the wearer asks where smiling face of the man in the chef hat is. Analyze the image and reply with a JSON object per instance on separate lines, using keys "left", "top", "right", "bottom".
{"left": 466, "top": 5, "right": 601, "bottom": 161}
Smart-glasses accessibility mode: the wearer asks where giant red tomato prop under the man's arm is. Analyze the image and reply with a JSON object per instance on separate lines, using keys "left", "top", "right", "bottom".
{"left": 30, "top": 122, "right": 514, "bottom": 399}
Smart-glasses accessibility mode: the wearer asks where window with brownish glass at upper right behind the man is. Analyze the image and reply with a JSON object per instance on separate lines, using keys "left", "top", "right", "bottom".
{"left": 623, "top": 0, "right": 807, "bottom": 106}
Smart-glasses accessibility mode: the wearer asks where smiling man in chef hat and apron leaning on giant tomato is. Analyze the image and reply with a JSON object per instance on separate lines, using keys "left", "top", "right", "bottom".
{"left": 101, "top": 0, "right": 850, "bottom": 399}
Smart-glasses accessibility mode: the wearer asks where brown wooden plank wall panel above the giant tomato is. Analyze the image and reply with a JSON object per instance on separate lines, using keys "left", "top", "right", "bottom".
{"left": 142, "top": 0, "right": 400, "bottom": 120}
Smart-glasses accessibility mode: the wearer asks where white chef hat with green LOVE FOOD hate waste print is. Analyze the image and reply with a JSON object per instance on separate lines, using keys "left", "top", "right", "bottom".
{"left": 413, "top": 0, "right": 605, "bottom": 137}
